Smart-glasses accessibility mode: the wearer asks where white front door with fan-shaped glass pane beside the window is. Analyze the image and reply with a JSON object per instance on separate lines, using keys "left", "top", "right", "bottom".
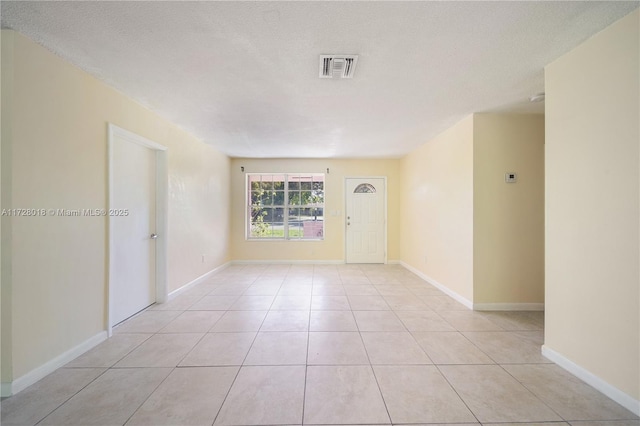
{"left": 345, "top": 178, "right": 386, "bottom": 263}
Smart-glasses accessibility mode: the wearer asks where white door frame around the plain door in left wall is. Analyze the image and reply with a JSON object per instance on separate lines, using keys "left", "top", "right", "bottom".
{"left": 107, "top": 123, "right": 169, "bottom": 336}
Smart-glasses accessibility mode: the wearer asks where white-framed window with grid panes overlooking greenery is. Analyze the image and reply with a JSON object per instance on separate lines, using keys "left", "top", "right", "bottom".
{"left": 247, "top": 173, "right": 324, "bottom": 240}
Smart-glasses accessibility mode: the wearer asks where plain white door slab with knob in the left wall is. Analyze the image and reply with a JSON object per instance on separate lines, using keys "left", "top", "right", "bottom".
{"left": 109, "top": 134, "right": 157, "bottom": 326}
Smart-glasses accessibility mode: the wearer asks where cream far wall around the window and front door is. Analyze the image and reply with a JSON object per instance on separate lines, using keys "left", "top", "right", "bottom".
{"left": 231, "top": 158, "right": 400, "bottom": 262}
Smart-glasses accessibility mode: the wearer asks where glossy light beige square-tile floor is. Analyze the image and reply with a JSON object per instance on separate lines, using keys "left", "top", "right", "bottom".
{"left": 1, "top": 265, "right": 640, "bottom": 426}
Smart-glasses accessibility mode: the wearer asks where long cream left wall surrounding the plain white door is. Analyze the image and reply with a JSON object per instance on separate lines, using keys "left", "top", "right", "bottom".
{"left": 2, "top": 30, "right": 230, "bottom": 381}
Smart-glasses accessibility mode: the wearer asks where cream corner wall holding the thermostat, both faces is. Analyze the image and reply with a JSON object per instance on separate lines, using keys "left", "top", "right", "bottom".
{"left": 400, "top": 114, "right": 544, "bottom": 309}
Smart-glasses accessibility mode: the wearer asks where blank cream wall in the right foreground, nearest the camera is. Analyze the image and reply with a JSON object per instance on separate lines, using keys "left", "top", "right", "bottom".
{"left": 545, "top": 10, "right": 640, "bottom": 401}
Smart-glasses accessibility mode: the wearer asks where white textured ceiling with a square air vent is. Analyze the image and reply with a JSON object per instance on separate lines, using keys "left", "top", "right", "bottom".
{"left": 1, "top": 0, "right": 640, "bottom": 158}
